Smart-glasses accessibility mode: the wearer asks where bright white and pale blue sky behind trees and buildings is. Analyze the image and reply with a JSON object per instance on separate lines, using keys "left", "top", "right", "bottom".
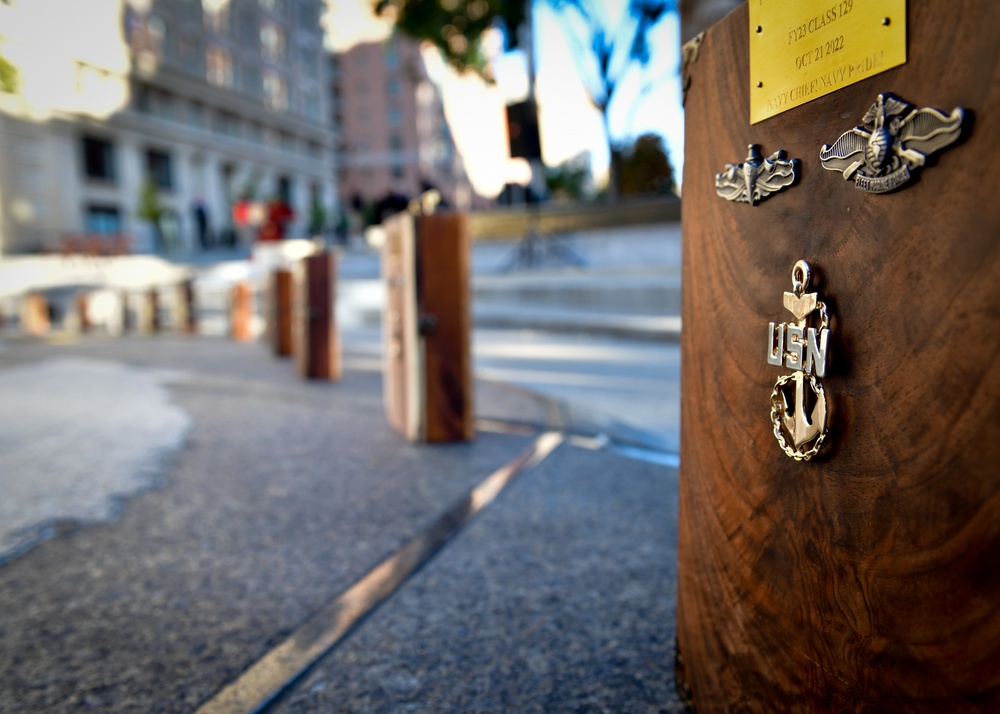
{"left": 326, "top": 0, "right": 684, "bottom": 196}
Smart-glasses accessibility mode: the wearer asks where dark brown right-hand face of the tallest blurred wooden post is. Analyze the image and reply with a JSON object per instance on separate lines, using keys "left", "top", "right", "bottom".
{"left": 417, "top": 213, "right": 475, "bottom": 442}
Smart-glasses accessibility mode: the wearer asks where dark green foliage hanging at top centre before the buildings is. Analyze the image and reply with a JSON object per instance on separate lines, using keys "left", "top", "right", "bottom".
{"left": 375, "top": 0, "right": 524, "bottom": 81}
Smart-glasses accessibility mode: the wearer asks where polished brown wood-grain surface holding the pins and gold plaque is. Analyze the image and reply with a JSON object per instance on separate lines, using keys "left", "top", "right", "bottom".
{"left": 678, "top": 0, "right": 1000, "bottom": 712}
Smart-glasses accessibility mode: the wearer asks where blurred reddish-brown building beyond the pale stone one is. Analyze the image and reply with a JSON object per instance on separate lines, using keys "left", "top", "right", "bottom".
{"left": 331, "top": 34, "right": 476, "bottom": 222}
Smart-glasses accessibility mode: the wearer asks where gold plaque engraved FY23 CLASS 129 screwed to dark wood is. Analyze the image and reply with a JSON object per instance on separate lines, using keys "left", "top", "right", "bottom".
{"left": 749, "top": 0, "right": 906, "bottom": 124}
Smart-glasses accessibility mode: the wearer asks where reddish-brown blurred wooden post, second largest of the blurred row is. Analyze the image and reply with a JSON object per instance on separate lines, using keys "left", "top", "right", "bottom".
{"left": 292, "top": 252, "right": 340, "bottom": 380}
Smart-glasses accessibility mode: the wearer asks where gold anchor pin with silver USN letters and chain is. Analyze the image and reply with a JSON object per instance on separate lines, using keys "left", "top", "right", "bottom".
{"left": 767, "top": 260, "right": 830, "bottom": 461}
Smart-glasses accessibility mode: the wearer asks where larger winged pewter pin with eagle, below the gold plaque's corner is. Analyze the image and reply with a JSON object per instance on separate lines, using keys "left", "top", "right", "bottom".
{"left": 819, "top": 93, "right": 965, "bottom": 193}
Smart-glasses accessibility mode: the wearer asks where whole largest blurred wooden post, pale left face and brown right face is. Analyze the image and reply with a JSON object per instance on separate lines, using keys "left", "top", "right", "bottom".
{"left": 382, "top": 213, "right": 475, "bottom": 442}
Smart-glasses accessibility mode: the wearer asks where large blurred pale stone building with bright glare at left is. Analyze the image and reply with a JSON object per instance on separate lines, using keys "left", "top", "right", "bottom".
{"left": 0, "top": 0, "right": 337, "bottom": 252}
